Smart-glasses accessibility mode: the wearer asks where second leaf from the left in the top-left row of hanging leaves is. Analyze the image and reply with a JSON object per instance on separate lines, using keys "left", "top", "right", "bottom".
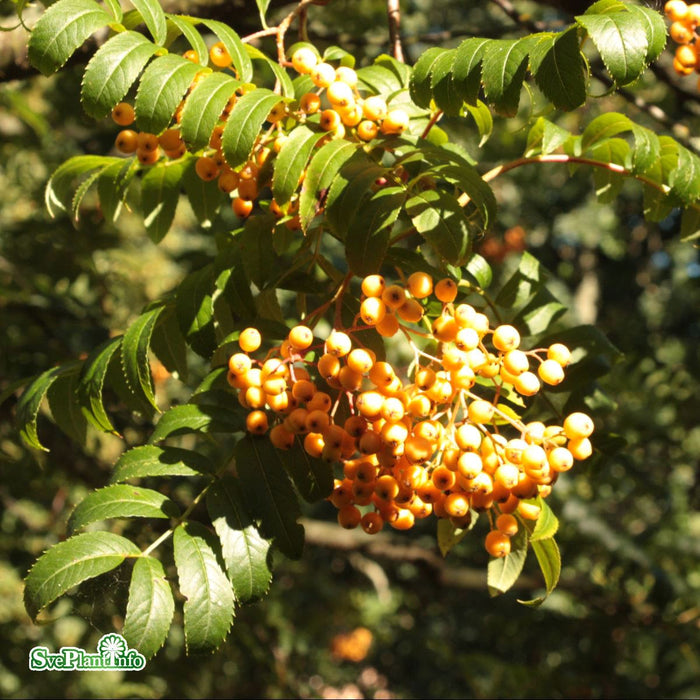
{"left": 80, "top": 32, "right": 158, "bottom": 119}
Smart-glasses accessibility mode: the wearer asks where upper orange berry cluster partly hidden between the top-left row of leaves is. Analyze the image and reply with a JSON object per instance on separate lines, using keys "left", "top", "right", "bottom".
{"left": 112, "top": 42, "right": 409, "bottom": 224}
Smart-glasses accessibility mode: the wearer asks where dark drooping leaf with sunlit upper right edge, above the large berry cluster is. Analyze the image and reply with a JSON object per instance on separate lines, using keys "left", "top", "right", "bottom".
{"left": 345, "top": 187, "right": 406, "bottom": 276}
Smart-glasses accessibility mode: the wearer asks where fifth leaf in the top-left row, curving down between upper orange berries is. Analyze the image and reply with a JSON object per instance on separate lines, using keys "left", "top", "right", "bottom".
{"left": 222, "top": 88, "right": 281, "bottom": 168}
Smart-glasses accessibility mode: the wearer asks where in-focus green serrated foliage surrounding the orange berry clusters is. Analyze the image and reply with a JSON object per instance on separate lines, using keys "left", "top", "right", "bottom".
{"left": 0, "top": 0, "right": 698, "bottom": 696}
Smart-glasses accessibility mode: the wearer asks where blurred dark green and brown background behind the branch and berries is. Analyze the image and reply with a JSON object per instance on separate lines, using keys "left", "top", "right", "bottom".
{"left": 0, "top": 0, "right": 700, "bottom": 698}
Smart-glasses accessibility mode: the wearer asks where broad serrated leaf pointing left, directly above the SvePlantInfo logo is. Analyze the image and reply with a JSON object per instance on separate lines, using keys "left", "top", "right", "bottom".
{"left": 24, "top": 532, "right": 141, "bottom": 620}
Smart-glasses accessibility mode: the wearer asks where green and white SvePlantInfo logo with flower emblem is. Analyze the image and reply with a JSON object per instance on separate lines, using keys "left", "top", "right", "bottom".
{"left": 29, "top": 633, "right": 146, "bottom": 671}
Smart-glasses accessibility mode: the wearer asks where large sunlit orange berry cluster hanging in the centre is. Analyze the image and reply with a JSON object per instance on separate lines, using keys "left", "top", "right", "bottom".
{"left": 228, "top": 272, "right": 593, "bottom": 557}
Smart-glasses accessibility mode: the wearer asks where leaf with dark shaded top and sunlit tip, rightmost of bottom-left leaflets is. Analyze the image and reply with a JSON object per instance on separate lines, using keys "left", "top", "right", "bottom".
{"left": 207, "top": 475, "right": 272, "bottom": 603}
